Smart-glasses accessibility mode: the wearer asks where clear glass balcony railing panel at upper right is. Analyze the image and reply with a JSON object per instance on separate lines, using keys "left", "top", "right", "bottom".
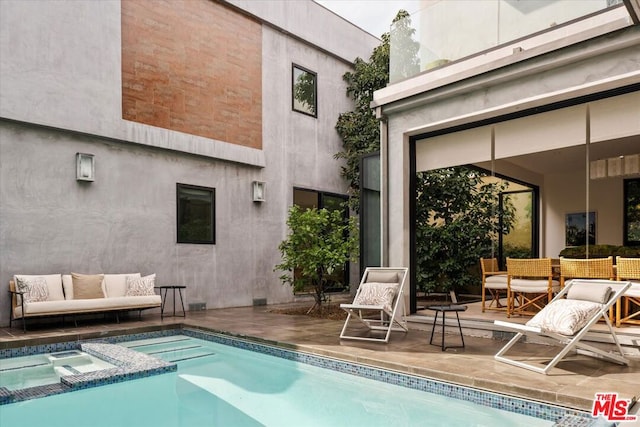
{"left": 389, "top": 0, "right": 622, "bottom": 83}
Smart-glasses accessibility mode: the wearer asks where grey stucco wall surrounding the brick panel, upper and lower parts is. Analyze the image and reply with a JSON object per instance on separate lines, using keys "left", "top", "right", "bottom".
{"left": 0, "top": 0, "right": 378, "bottom": 324}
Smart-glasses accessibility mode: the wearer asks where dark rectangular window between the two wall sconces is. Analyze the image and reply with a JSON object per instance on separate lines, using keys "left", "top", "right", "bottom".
{"left": 176, "top": 184, "right": 216, "bottom": 244}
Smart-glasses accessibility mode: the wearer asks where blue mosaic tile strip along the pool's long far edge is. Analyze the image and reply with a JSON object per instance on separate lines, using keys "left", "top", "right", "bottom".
{"left": 182, "top": 329, "right": 596, "bottom": 427}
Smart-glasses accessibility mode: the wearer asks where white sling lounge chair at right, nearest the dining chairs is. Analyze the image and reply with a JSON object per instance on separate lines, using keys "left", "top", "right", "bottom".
{"left": 494, "top": 279, "right": 631, "bottom": 375}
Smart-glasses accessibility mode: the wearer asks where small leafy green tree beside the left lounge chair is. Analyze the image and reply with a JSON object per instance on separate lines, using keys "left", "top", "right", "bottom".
{"left": 275, "top": 206, "right": 358, "bottom": 312}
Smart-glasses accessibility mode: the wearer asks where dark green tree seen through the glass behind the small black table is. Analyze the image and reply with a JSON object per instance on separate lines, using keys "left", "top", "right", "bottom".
{"left": 416, "top": 166, "right": 515, "bottom": 291}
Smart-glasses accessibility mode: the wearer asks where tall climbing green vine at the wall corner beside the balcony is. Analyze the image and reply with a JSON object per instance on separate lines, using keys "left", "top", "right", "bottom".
{"left": 334, "top": 10, "right": 417, "bottom": 212}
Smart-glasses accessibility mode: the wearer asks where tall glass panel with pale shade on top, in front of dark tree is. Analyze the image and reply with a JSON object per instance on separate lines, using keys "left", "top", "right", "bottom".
{"left": 416, "top": 126, "right": 500, "bottom": 300}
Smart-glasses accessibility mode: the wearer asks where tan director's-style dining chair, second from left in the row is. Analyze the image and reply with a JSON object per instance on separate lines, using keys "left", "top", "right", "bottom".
{"left": 507, "top": 258, "right": 560, "bottom": 317}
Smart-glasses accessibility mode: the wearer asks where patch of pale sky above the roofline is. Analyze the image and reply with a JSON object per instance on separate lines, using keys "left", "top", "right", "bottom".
{"left": 315, "top": 0, "right": 420, "bottom": 37}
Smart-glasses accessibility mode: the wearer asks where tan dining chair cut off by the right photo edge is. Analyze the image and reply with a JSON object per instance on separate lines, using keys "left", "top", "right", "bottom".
{"left": 616, "top": 257, "right": 640, "bottom": 327}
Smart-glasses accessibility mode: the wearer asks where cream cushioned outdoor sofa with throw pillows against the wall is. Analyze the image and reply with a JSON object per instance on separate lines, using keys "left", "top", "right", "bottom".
{"left": 9, "top": 273, "right": 162, "bottom": 331}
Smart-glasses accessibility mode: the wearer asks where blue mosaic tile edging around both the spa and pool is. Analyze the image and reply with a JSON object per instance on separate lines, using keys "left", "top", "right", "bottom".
{"left": 0, "top": 324, "right": 602, "bottom": 427}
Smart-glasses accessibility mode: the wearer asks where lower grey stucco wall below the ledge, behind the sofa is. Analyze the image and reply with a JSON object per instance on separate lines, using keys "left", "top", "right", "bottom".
{"left": 0, "top": 121, "right": 282, "bottom": 310}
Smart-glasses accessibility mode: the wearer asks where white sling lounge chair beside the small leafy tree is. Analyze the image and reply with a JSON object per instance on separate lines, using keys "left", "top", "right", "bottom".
{"left": 340, "top": 267, "right": 408, "bottom": 343}
